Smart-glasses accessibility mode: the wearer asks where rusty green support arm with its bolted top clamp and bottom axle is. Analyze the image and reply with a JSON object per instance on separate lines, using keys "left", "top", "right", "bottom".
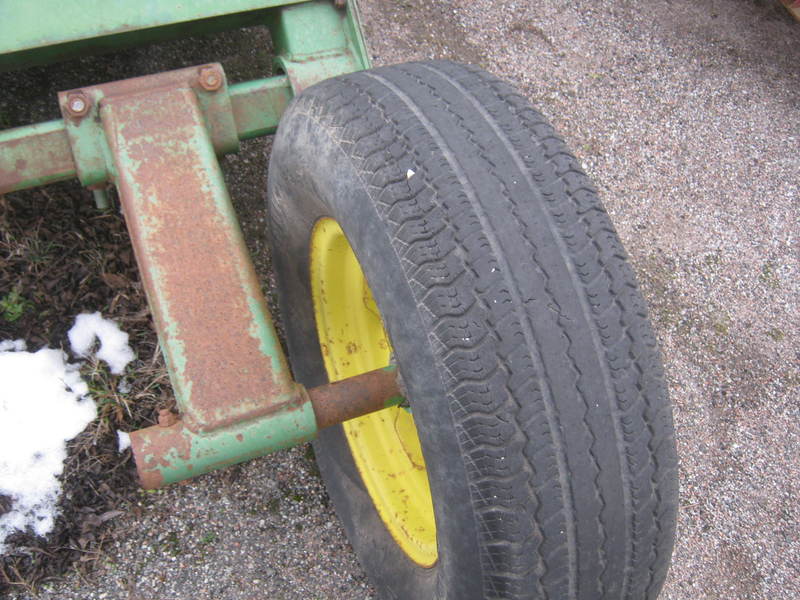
{"left": 77, "top": 65, "right": 400, "bottom": 487}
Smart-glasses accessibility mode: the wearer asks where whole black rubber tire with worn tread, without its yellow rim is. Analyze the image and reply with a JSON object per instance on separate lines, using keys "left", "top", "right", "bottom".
{"left": 269, "top": 62, "right": 677, "bottom": 600}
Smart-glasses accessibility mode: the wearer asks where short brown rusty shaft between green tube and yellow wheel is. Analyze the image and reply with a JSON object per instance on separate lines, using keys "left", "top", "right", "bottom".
{"left": 308, "top": 369, "right": 400, "bottom": 429}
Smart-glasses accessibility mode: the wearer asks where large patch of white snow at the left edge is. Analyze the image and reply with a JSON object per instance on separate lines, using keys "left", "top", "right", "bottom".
{"left": 0, "top": 342, "right": 97, "bottom": 554}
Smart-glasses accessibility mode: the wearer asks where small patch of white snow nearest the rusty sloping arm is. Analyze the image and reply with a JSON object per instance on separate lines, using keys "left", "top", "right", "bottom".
{"left": 67, "top": 312, "right": 134, "bottom": 375}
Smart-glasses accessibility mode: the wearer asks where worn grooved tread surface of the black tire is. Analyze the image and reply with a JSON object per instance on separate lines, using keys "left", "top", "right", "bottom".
{"left": 282, "top": 62, "right": 677, "bottom": 600}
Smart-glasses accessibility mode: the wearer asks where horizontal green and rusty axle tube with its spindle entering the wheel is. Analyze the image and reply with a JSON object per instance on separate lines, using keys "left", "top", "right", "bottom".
{"left": 130, "top": 367, "right": 403, "bottom": 489}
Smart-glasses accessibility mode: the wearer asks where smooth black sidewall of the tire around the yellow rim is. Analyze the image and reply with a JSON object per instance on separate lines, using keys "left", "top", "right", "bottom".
{"left": 268, "top": 105, "right": 483, "bottom": 600}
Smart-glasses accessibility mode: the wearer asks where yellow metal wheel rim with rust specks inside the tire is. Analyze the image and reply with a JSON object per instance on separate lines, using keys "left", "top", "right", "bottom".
{"left": 311, "top": 218, "right": 438, "bottom": 567}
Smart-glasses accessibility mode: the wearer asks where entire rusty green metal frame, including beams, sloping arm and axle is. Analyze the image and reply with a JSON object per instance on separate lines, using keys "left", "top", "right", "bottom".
{"left": 0, "top": 0, "right": 388, "bottom": 487}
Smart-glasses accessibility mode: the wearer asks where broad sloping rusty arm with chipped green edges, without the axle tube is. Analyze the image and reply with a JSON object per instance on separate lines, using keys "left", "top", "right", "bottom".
{"left": 94, "top": 65, "right": 294, "bottom": 431}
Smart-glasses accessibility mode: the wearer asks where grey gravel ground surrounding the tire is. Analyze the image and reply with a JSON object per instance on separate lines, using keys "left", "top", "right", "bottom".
{"left": 3, "top": 0, "right": 800, "bottom": 600}
